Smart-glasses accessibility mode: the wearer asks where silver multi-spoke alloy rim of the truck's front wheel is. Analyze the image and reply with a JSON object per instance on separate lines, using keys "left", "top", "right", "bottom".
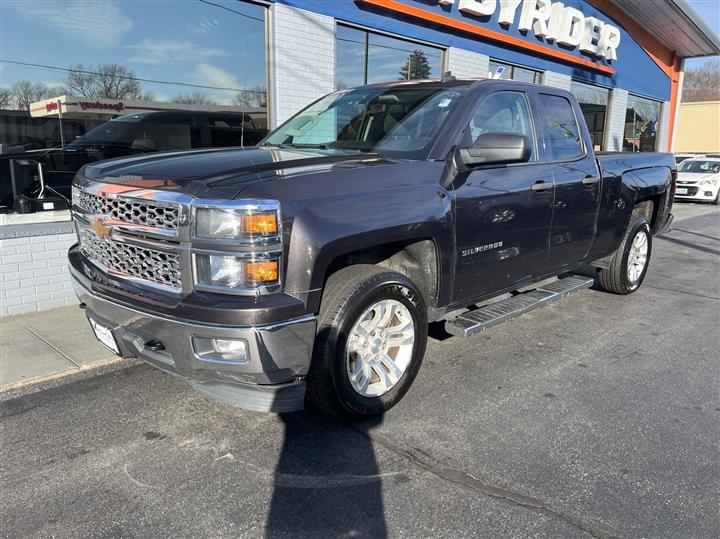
{"left": 345, "top": 299, "right": 415, "bottom": 397}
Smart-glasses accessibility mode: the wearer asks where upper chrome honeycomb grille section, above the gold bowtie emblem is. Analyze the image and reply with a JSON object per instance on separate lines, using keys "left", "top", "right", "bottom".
{"left": 72, "top": 187, "right": 180, "bottom": 230}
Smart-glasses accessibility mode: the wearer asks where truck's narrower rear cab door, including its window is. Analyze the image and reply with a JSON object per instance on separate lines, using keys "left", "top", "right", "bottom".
{"left": 537, "top": 91, "right": 602, "bottom": 271}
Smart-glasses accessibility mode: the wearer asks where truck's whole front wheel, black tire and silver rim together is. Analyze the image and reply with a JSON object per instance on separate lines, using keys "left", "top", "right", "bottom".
{"left": 307, "top": 265, "right": 427, "bottom": 417}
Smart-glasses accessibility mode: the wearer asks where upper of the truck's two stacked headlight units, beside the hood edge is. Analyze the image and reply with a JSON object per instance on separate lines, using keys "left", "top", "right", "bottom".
{"left": 195, "top": 207, "right": 280, "bottom": 243}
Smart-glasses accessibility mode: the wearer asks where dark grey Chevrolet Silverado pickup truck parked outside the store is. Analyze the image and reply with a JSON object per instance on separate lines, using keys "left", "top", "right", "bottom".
{"left": 69, "top": 76, "right": 676, "bottom": 417}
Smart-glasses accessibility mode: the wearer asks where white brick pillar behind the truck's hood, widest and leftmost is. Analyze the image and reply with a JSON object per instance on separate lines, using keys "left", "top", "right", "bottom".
{"left": 270, "top": 4, "right": 335, "bottom": 127}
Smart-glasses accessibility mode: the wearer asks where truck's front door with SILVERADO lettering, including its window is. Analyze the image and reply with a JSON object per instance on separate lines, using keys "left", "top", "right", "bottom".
{"left": 453, "top": 85, "right": 554, "bottom": 303}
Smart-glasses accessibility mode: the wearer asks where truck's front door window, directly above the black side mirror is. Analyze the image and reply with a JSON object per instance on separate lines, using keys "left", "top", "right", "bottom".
{"left": 469, "top": 92, "right": 536, "bottom": 161}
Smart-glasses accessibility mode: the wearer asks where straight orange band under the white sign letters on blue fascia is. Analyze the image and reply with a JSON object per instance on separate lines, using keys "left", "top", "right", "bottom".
{"left": 356, "top": 0, "right": 616, "bottom": 75}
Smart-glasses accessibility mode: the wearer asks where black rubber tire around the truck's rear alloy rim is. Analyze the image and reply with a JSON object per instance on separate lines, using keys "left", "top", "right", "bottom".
{"left": 597, "top": 215, "right": 652, "bottom": 295}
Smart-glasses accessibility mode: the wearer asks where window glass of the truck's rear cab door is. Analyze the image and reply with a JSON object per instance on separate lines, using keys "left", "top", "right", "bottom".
{"left": 540, "top": 94, "right": 583, "bottom": 161}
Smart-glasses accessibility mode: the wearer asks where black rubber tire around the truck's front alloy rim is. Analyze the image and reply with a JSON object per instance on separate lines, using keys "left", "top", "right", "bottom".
{"left": 307, "top": 265, "right": 428, "bottom": 418}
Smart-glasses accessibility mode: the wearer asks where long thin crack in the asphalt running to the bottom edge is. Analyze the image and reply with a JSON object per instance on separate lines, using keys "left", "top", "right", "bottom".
{"left": 359, "top": 431, "right": 622, "bottom": 539}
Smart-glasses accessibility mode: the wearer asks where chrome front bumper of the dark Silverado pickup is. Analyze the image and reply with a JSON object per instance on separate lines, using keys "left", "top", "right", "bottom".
{"left": 71, "top": 271, "right": 316, "bottom": 412}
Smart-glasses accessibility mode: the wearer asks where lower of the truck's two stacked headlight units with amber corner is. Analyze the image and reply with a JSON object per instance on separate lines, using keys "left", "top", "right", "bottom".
{"left": 194, "top": 253, "right": 281, "bottom": 292}
